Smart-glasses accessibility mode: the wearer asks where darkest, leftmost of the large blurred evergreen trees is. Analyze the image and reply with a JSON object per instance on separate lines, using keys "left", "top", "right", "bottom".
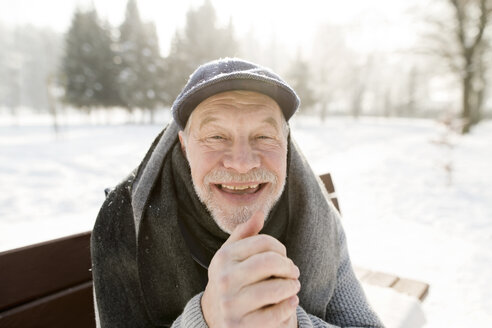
{"left": 62, "top": 9, "right": 120, "bottom": 111}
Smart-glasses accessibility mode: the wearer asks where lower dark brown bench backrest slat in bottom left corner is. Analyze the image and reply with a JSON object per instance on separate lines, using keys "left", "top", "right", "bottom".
{"left": 0, "top": 281, "right": 96, "bottom": 328}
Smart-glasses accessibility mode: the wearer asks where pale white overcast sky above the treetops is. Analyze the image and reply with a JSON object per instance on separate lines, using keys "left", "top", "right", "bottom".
{"left": 0, "top": 0, "right": 425, "bottom": 55}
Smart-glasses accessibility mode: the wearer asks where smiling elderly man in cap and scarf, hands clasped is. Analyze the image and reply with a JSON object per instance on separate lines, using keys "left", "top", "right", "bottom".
{"left": 92, "top": 59, "right": 381, "bottom": 328}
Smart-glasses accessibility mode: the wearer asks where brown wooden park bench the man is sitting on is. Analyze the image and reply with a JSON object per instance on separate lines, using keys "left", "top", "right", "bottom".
{"left": 0, "top": 174, "right": 429, "bottom": 328}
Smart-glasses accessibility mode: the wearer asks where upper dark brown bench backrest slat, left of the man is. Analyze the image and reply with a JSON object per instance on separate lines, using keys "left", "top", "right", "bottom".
{"left": 0, "top": 232, "right": 92, "bottom": 311}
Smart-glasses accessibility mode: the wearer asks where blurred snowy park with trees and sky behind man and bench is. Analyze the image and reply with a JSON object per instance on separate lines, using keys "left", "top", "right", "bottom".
{"left": 0, "top": 0, "right": 492, "bottom": 327}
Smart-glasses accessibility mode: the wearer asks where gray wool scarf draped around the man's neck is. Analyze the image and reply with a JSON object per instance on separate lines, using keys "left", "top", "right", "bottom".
{"left": 132, "top": 122, "right": 339, "bottom": 325}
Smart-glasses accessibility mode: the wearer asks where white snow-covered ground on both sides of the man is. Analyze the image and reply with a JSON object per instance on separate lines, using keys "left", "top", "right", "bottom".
{"left": 0, "top": 111, "right": 492, "bottom": 328}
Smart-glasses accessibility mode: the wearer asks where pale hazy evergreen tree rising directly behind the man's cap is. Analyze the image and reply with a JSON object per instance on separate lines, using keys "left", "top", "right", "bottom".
{"left": 166, "top": 0, "right": 238, "bottom": 105}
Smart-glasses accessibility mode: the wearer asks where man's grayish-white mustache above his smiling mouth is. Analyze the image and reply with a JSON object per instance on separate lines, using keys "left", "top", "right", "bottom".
{"left": 204, "top": 168, "right": 278, "bottom": 184}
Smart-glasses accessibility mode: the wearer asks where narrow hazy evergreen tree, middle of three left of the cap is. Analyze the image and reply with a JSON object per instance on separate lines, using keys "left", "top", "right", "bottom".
{"left": 118, "top": 0, "right": 163, "bottom": 121}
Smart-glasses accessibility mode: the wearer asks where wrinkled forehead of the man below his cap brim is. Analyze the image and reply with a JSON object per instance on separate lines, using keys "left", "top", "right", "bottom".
{"left": 187, "top": 90, "right": 283, "bottom": 128}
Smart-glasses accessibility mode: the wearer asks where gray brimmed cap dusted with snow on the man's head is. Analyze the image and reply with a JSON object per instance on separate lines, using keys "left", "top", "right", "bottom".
{"left": 171, "top": 58, "right": 300, "bottom": 129}
